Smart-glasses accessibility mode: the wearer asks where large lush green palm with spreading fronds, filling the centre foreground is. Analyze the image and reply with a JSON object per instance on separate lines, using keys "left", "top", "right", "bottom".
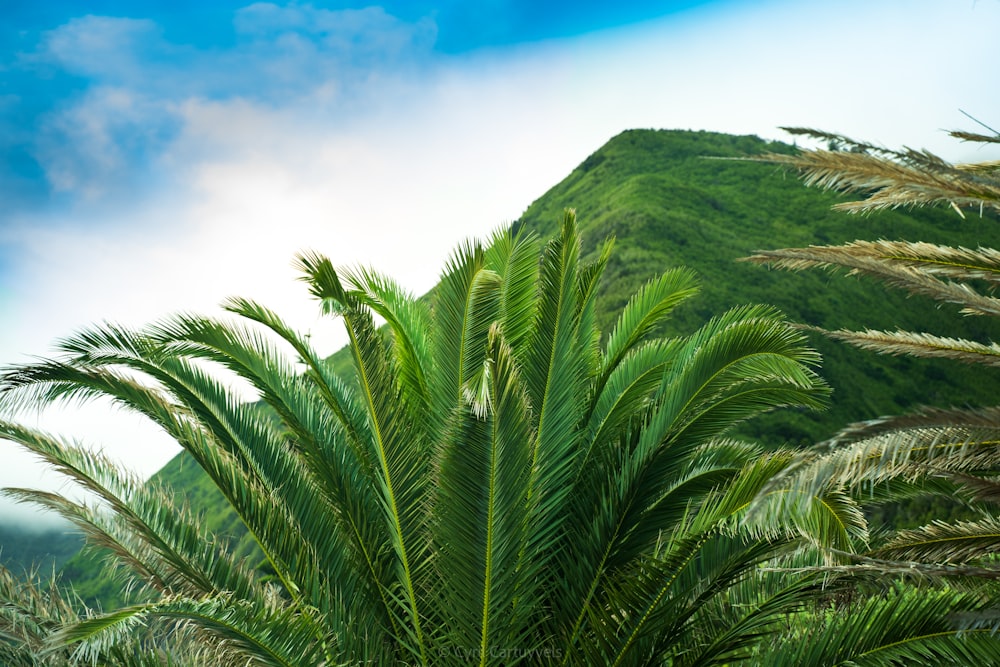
{"left": 0, "top": 216, "right": 850, "bottom": 665}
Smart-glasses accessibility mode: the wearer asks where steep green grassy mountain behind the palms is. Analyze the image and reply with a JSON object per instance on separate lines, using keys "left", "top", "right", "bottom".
{"left": 56, "top": 130, "right": 1000, "bottom": 598}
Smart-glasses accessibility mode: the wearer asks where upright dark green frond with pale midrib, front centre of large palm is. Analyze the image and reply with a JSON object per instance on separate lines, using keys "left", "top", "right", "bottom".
{"left": 435, "top": 325, "right": 543, "bottom": 664}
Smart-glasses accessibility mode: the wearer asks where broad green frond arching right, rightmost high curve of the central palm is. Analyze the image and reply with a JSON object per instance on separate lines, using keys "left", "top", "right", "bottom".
{"left": 556, "top": 307, "right": 825, "bottom": 659}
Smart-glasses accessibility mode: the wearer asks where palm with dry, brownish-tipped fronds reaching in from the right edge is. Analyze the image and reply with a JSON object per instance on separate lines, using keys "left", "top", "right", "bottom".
{"left": 748, "top": 124, "right": 1000, "bottom": 664}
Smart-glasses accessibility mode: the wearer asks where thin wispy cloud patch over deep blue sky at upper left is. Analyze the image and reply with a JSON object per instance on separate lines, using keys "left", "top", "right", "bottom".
{"left": 21, "top": 3, "right": 436, "bottom": 200}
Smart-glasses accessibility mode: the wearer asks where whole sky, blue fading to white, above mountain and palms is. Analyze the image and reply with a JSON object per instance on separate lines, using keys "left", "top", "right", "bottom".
{"left": 0, "top": 0, "right": 1000, "bottom": 520}
